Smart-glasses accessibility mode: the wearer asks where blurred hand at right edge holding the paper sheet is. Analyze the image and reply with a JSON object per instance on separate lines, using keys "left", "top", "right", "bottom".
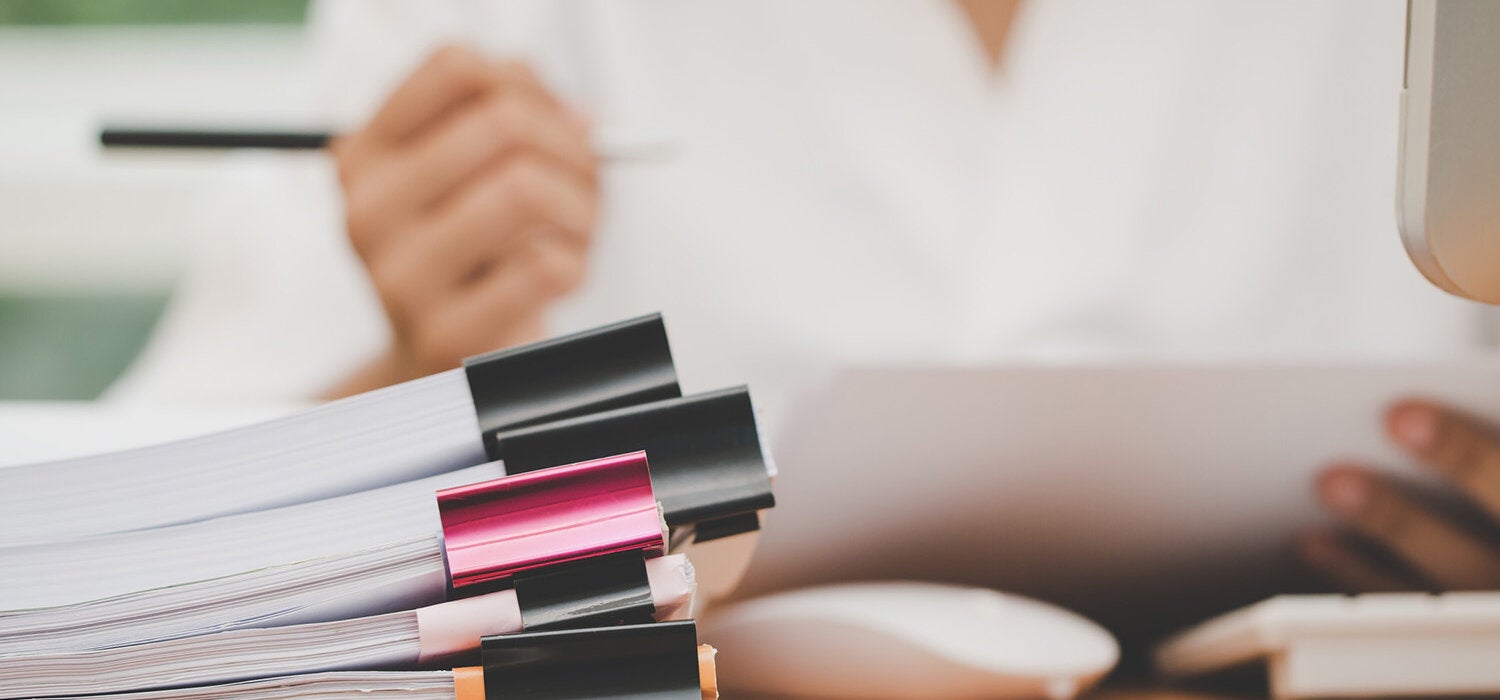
{"left": 1302, "top": 400, "right": 1500, "bottom": 592}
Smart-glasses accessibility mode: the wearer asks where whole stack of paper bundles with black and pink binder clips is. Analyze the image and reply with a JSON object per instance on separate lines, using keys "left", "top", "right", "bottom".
{"left": 0, "top": 316, "right": 774, "bottom": 699}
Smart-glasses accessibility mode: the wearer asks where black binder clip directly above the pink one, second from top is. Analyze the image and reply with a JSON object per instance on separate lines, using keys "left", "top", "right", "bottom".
{"left": 485, "top": 387, "right": 776, "bottom": 549}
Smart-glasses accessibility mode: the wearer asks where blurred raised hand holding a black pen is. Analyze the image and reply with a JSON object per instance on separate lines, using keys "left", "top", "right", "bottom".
{"left": 332, "top": 46, "right": 599, "bottom": 396}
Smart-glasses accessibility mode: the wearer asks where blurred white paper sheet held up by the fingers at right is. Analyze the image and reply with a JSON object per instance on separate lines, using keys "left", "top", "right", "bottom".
{"left": 743, "top": 360, "right": 1500, "bottom": 628}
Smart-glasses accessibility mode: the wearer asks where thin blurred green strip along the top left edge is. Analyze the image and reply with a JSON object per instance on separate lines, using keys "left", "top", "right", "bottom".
{"left": 0, "top": 0, "right": 308, "bottom": 25}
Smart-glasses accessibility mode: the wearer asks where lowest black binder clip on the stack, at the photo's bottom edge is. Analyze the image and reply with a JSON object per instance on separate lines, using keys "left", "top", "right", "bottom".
{"left": 480, "top": 621, "right": 704, "bottom": 700}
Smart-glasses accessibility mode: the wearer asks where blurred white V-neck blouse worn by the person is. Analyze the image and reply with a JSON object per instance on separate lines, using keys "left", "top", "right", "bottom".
{"left": 116, "top": 0, "right": 1490, "bottom": 416}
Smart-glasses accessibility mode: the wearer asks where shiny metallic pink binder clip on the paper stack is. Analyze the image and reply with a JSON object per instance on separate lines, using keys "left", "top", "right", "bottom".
{"left": 438, "top": 453, "right": 665, "bottom": 591}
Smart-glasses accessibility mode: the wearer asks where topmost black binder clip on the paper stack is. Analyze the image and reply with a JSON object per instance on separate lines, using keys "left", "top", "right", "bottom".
{"left": 464, "top": 313, "right": 683, "bottom": 434}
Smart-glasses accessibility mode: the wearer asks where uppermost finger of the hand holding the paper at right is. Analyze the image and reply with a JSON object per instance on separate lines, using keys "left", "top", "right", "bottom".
{"left": 1386, "top": 400, "right": 1500, "bottom": 522}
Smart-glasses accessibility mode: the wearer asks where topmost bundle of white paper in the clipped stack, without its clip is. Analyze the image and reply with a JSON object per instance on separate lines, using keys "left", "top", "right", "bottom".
{"left": 0, "top": 370, "right": 485, "bottom": 546}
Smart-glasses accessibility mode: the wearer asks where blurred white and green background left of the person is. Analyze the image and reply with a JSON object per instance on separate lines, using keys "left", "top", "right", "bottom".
{"left": 0, "top": 0, "right": 308, "bottom": 400}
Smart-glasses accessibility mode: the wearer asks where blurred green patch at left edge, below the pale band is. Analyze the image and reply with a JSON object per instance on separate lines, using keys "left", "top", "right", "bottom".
{"left": 0, "top": 294, "right": 167, "bottom": 400}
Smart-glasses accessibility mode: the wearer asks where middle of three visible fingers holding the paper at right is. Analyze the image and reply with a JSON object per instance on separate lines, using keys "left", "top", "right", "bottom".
{"left": 1317, "top": 465, "right": 1500, "bottom": 591}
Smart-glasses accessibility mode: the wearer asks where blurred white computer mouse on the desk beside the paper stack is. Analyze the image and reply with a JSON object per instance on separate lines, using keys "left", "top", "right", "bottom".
{"left": 699, "top": 582, "right": 1119, "bottom": 699}
